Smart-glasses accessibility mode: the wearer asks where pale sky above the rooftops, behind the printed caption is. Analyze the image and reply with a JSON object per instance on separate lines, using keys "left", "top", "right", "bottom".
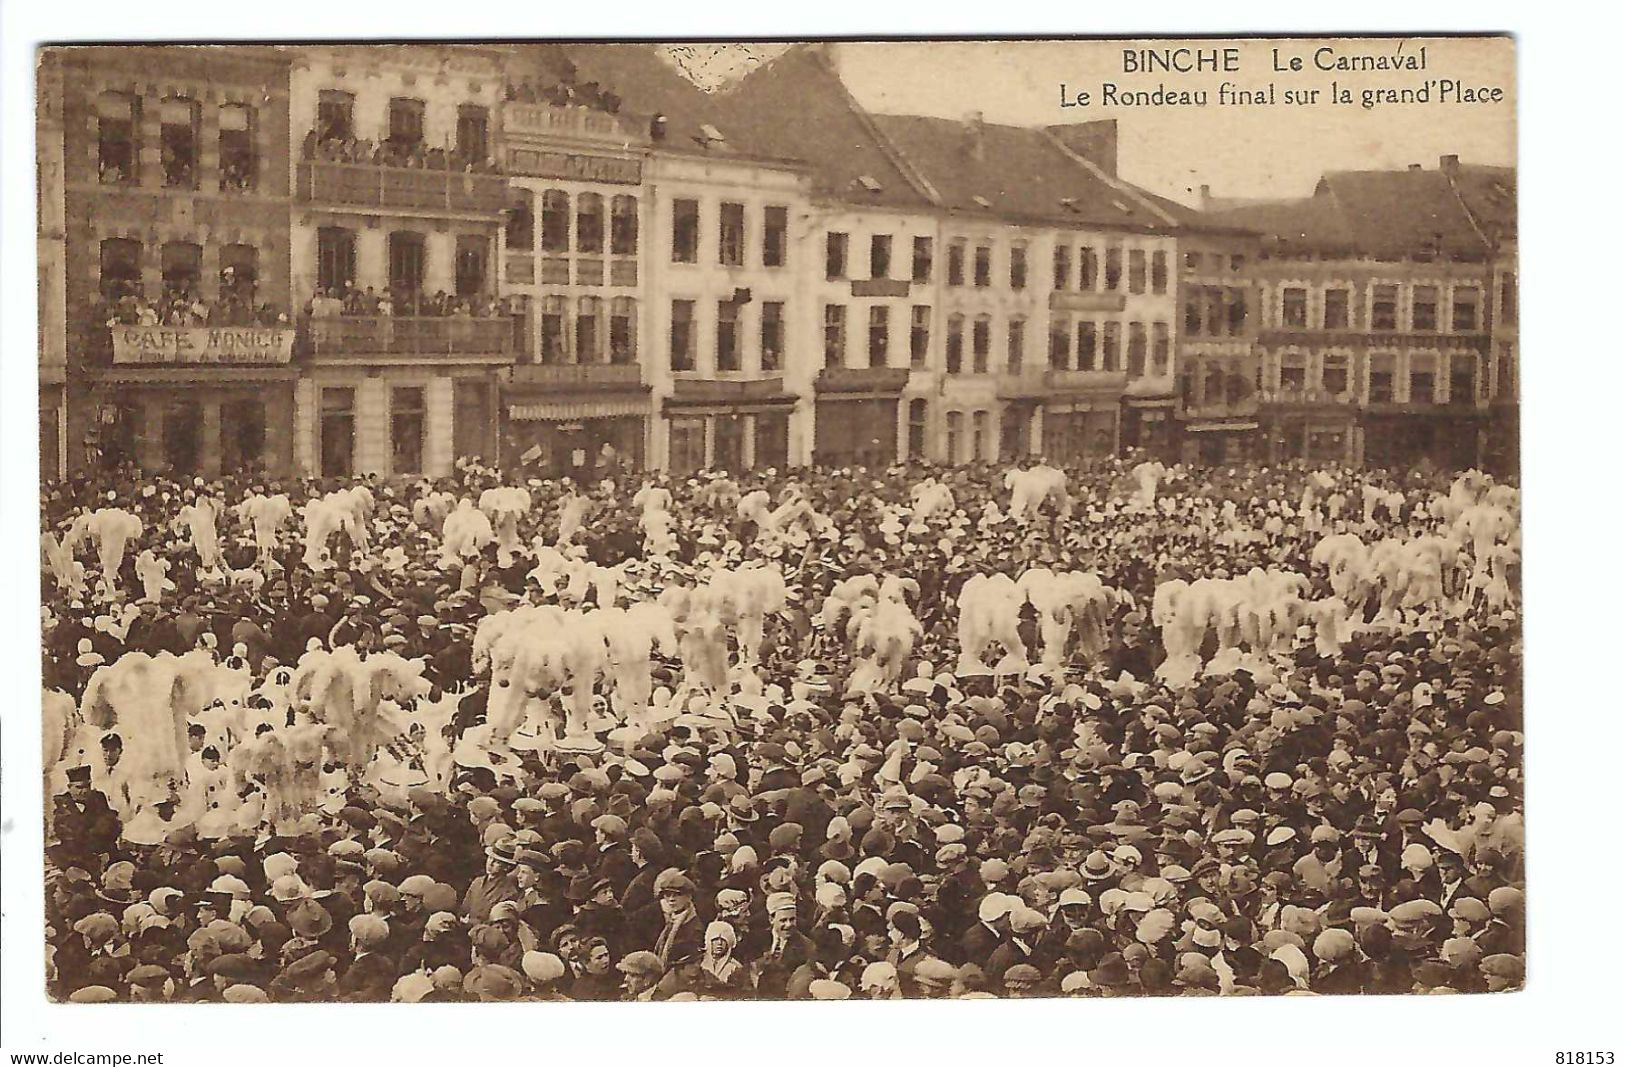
{"left": 835, "top": 37, "right": 1516, "bottom": 205}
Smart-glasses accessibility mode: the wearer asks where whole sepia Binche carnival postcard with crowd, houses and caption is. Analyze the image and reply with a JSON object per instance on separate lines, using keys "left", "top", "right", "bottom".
{"left": 19, "top": 34, "right": 1527, "bottom": 1013}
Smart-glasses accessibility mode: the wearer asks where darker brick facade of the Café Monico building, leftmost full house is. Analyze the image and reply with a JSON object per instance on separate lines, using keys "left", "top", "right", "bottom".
{"left": 60, "top": 47, "right": 294, "bottom": 474}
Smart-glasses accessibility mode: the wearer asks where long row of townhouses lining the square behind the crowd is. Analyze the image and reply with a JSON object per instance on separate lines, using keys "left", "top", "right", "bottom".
{"left": 41, "top": 45, "right": 1516, "bottom": 476}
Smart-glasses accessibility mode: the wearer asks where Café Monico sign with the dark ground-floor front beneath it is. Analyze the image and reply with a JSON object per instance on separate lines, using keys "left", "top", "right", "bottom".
{"left": 80, "top": 326, "right": 296, "bottom": 476}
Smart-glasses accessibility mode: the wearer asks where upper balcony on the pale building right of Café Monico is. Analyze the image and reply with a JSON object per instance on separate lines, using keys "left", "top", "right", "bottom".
{"left": 297, "top": 161, "right": 509, "bottom": 216}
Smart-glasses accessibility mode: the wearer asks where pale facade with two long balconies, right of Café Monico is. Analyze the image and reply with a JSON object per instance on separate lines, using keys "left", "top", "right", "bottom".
{"left": 288, "top": 45, "right": 510, "bottom": 476}
